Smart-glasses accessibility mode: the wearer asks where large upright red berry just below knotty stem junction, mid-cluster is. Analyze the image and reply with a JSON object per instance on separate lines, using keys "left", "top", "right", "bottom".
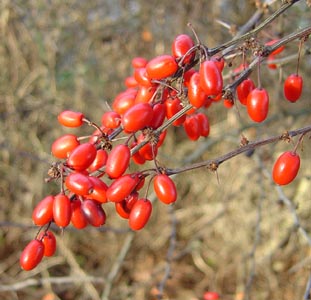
{"left": 105, "top": 144, "right": 131, "bottom": 178}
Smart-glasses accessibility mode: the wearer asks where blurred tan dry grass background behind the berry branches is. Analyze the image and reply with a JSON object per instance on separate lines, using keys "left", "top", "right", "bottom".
{"left": 0, "top": 0, "right": 311, "bottom": 300}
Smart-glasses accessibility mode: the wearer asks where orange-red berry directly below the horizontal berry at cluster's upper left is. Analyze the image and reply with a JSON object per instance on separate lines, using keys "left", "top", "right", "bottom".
{"left": 52, "top": 134, "right": 80, "bottom": 159}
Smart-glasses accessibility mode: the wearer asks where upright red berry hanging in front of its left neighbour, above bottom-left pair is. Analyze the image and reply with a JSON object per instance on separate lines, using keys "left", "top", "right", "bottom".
{"left": 53, "top": 193, "right": 71, "bottom": 227}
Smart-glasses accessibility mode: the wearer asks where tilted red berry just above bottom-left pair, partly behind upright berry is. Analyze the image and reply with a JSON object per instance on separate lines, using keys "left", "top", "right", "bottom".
{"left": 32, "top": 195, "right": 54, "bottom": 226}
